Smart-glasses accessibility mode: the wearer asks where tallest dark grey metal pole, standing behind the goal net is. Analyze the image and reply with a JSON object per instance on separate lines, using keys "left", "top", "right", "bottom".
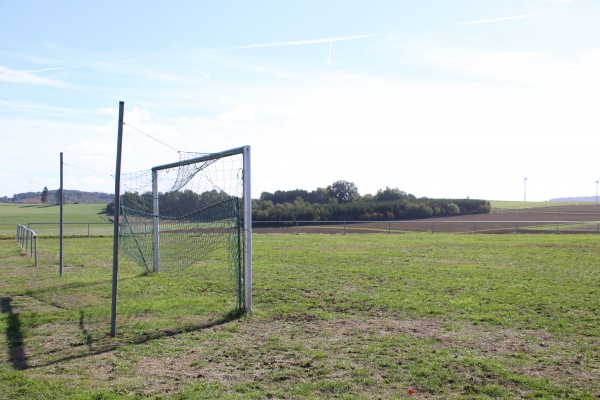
{"left": 110, "top": 101, "right": 125, "bottom": 337}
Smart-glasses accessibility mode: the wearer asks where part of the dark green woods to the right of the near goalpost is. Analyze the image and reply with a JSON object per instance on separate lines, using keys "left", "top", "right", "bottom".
{"left": 252, "top": 181, "right": 491, "bottom": 221}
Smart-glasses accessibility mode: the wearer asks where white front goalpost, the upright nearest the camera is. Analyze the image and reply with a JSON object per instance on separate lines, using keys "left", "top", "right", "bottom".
{"left": 243, "top": 146, "right": 252, "bottom": 312}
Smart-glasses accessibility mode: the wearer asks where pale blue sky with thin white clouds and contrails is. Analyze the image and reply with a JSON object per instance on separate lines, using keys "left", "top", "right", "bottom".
{"left": 0, "top": 0, "right": 600, "bottom": 201}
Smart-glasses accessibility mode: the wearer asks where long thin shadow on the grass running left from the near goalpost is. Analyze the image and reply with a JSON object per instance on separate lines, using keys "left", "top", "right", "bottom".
{"left": 25, "top": 303, "right": 244, "bottom": 369}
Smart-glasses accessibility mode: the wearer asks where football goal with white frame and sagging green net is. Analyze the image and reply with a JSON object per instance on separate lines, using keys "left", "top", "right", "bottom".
{"left": 119, "top": 146, "right": 252, "bottom": 311}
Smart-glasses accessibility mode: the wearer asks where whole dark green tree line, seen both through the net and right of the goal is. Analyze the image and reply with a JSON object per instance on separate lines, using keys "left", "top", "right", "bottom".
{"left": 106, "top": 181, "right": 491, "bottom": 222}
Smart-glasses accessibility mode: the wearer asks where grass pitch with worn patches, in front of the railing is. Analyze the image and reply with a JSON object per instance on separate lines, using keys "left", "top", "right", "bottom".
{"left": 0, "top": 234, "right": 600, "bottom": 399}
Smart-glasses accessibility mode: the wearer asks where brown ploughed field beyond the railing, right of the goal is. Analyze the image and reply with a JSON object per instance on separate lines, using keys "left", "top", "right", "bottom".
{"left": 252, "top": 204, "right": 600, "bottom": 234}
